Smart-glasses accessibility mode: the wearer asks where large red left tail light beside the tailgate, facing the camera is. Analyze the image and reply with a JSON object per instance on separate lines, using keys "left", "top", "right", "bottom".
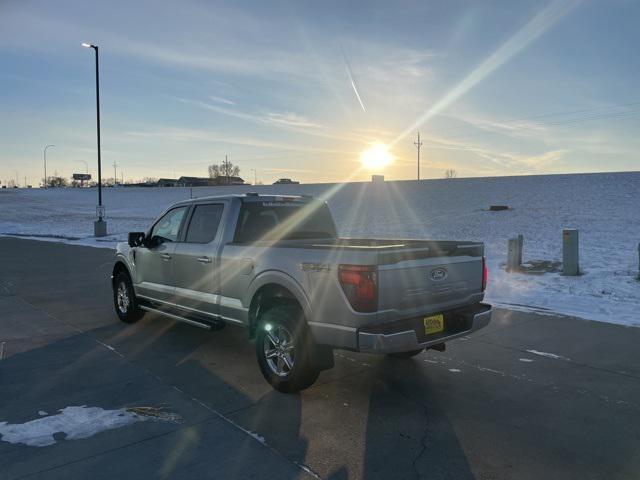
{"left": 338, "top": 265, "right": 378, "bottom": 312}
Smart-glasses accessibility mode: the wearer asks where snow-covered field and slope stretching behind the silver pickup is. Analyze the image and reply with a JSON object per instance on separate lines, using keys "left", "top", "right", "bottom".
{"left": 0, "top": 173, "right": 640, "bottom": 325}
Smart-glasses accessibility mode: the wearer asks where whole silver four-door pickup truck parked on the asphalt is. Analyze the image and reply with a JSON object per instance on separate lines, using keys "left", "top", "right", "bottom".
{"left": 112, "top": 193, "right": 491, "bottom": 392}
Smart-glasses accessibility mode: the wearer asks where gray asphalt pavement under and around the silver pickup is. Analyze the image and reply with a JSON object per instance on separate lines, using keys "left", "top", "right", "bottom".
{"left": 0, "top": 238, "right": 640, "bottom": 479}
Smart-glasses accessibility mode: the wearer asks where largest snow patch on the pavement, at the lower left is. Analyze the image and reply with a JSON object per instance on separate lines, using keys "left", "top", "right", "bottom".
{"left": 0, "top": 405, "right": 144, "bottom": 447}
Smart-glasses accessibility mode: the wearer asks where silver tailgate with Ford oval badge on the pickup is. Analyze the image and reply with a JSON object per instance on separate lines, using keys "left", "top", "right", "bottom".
{"left": 378, "top": 251, "right": 482, "bottom": 311}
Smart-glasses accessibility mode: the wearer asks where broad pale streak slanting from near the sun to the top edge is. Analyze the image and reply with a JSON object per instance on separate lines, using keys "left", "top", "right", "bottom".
{"left": 391, "top": 0, "right": 581, "bottom": 145}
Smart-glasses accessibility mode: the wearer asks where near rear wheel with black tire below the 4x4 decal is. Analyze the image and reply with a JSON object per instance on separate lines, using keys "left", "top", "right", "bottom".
{"left": 256, "top": 305, "right": 320, "bottom": 393}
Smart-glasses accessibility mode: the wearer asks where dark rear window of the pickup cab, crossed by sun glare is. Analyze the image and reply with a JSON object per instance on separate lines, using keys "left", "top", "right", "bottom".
{"left": 234, "top": 202, "right": 337, "bottom": 243}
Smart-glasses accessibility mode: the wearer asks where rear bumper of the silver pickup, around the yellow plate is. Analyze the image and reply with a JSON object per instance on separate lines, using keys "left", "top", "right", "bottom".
{"left": 358, "top": 303, "right": 492, "bottom": 353}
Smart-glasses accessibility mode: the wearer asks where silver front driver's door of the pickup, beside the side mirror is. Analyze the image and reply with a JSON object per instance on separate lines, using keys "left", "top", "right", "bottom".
{"left": 136, "top": 206, "right": 188, "bottom": 302}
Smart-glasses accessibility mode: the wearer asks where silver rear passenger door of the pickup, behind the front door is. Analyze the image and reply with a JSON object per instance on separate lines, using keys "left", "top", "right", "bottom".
{"left": 173, "top": 201, "right": 226, "bottom": 316}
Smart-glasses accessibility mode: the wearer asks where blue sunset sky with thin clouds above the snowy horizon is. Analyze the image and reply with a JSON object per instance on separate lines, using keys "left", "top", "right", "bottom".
{"left": 0, "top": 0, "right": 640, "bottom": 186}
